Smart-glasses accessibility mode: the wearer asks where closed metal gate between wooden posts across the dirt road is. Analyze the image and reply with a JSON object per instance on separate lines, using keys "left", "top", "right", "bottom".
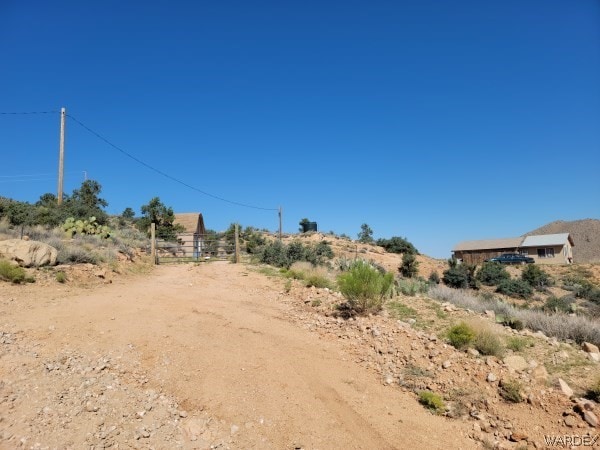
{"left": 156, "top": 233, "right": 236, "bottom": 264}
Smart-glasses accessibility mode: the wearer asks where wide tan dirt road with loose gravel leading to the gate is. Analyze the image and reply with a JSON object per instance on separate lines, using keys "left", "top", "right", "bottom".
{"left": 0, "top": 263, "right": 476, "bottom": 449}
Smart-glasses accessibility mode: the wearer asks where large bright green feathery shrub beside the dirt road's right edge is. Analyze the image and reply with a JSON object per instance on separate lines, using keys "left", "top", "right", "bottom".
{"left": 338, "top": 259, "right": 394, "bottom": 314}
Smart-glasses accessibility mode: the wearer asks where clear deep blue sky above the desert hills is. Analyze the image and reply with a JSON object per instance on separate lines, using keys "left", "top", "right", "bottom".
{"left": 0, "top": 0, "right": 600, "bottom": 258}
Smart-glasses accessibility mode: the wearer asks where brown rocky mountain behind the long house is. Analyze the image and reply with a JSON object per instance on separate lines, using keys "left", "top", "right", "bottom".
{"left": 524, "top": 219, "right": 600, "bottom": 263}
